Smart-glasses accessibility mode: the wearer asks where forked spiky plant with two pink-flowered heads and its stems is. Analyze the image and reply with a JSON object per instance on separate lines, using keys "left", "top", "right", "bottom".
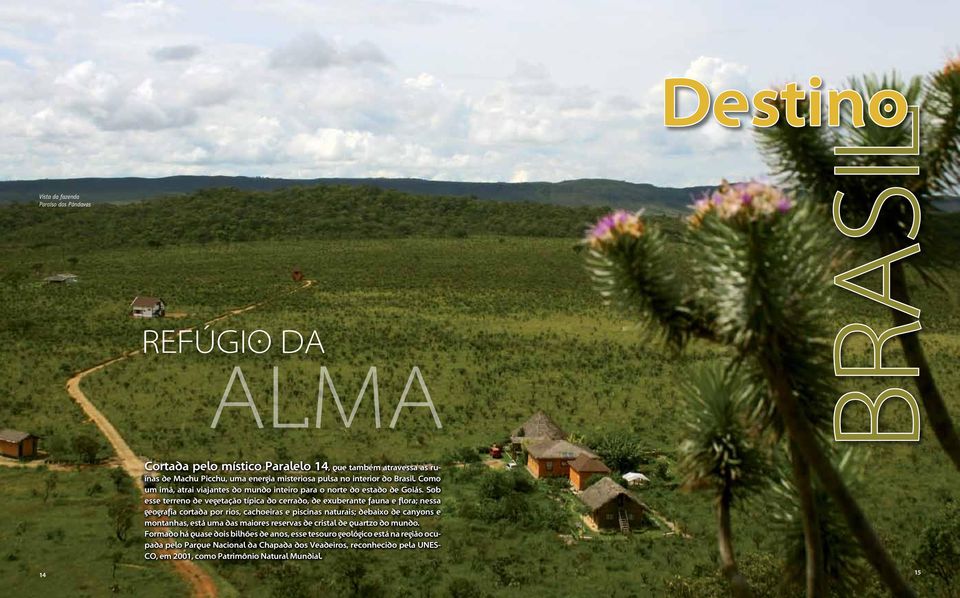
{"left": 586, "top": 183, "right": 913, "bottom": 596}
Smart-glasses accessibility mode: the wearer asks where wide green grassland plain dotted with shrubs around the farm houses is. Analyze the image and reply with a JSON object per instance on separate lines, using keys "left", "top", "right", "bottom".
{"left": 0, "top": 189, "right": 960, "bottom": 596}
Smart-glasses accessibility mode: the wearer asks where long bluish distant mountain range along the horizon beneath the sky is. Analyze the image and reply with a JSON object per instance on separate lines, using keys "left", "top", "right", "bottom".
{"left": 0, "top": 176, "right": 710, "bottom": 213}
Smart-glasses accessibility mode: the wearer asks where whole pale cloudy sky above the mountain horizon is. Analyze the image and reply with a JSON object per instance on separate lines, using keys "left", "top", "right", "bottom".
{"left": 0, "top": 0, "right": 960, "bottom": 186}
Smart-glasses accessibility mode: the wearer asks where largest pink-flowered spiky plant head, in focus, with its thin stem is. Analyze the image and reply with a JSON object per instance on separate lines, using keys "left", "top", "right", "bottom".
{"left": 690, "top": 183, "right": 836, "bottom": 596}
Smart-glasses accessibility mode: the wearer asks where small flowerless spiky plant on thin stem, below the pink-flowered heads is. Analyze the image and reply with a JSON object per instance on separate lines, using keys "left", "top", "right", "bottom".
{"left": 679, "top": 367, "right": 768, "bottom": 598}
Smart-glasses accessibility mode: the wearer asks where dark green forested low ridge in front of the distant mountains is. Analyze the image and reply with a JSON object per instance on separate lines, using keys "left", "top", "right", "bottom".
{"left": 0, "top": 185, "right": 604, "bottom": 248}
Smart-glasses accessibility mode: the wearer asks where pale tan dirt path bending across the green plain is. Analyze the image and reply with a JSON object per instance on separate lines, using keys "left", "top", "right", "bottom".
{"left": 67, "top": 280, "right": 314, "bottom": 598}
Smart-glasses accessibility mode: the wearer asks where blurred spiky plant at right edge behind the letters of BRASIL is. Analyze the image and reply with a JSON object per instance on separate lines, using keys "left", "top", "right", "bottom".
{"left": 758, "top": 58, "right": 960, "bottom": 471}
